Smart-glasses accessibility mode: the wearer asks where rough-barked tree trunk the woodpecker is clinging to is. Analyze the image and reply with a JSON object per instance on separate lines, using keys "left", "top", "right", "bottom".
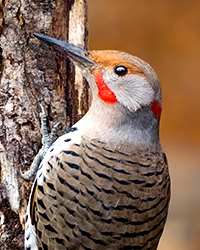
{"left": 0, "top": 0, "right": 88, "bottom": 250}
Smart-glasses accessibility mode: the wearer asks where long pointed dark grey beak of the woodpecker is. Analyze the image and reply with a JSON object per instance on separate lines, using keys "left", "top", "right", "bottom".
{"left": 33, "top": 33, "right": 97, "bottom": 68}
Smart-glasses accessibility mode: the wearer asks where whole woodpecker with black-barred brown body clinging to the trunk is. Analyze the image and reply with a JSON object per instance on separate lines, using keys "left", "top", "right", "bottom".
{"left": 25, "top": 34, "right": 170, "bottom": 250}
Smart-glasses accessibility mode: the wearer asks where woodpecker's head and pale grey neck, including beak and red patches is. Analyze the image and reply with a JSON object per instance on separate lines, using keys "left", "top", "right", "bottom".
{"left": 34, "top": 34, "right": 162, "bottom": 149}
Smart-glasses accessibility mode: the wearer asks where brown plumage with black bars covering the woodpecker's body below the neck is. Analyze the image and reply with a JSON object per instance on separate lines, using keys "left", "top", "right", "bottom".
{"left": 26, "top": 139, "right": 170, "bottom": 250}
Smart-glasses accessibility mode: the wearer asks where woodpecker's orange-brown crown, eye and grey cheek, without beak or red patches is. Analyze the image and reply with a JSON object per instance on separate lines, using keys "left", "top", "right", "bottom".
{"left": 91, "top": 51, "right": 161, "bottom": 112}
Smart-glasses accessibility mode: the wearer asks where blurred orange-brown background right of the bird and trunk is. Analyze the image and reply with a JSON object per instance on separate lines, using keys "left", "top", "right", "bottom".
{"left": 87, "top": 0, "right": 200, "bottom": 250}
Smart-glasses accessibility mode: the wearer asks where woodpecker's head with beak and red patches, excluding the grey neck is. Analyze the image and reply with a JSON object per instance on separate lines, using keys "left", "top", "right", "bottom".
{"left": 34, "top": 34, "right": 162, "bottom": 120}
